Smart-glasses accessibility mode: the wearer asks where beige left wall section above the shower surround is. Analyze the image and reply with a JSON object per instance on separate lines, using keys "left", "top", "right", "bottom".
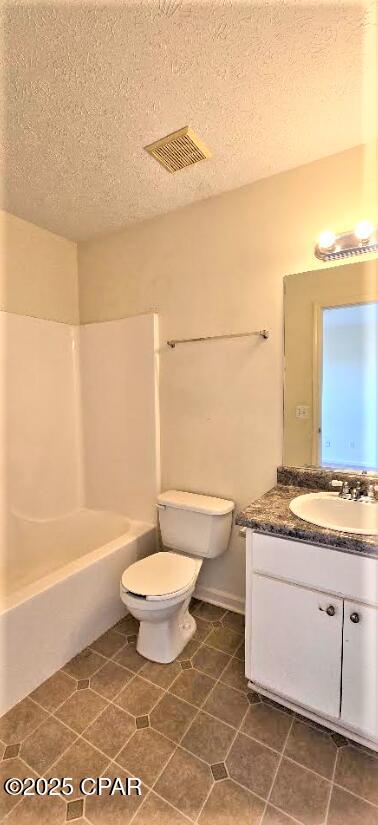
{"left": 0, "top": 211, "right": 79, "bottom": 323}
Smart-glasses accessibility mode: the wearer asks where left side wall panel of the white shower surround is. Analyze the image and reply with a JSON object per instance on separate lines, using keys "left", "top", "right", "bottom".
{"left": 0, "top": 312, "right": 83, "bottom": 520}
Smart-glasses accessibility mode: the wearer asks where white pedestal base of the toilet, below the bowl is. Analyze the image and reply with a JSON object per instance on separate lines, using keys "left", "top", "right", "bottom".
{"left": 136, "top": 597, "right": 197, "bottom": 664}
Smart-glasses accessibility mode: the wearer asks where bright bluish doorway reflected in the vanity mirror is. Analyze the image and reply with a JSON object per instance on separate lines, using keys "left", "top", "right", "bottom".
{"left": 319, "top": 301, "right": 378, "bottom": 470}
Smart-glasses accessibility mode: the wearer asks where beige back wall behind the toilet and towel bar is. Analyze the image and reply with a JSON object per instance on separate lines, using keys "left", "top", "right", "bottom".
{"left": 79, "top": 142, "right": 376, "bottom": 598}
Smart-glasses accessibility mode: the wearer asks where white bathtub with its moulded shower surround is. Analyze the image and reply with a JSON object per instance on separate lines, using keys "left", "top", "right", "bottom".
{"left": 0, "top": 312, "right": 160, "bottom": 712}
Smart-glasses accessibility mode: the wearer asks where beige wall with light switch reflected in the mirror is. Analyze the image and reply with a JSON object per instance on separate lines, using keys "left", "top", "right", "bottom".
{"left": 283, "top": 259, "right": 378, "bottom": 466}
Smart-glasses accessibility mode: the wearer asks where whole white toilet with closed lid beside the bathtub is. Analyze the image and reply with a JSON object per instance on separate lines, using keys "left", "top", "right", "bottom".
{"left": 120, "top": 490, "right": 234, "bottom": 664}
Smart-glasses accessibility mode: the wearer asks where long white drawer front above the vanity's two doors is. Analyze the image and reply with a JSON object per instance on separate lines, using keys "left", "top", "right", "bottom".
{"left": 248, "top": 530, "right": 378, "bottom": 605}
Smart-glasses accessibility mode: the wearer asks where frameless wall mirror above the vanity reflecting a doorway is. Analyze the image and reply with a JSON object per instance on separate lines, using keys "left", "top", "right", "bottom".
{"left": 283, "top": 259, "right": 378, "bottom": 472}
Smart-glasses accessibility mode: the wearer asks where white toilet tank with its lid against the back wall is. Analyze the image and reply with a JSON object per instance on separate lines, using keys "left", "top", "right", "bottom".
{"left": 157, "top": 490, "right": 234, "bottom": 558}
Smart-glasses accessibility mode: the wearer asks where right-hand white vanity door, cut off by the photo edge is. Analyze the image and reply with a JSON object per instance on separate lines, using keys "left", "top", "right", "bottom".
{"left": 341, "top": 601, "right": 378, "bottom": 740}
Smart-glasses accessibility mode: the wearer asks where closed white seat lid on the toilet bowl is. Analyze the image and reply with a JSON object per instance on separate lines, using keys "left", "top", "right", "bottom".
{"left": 122, "top": 552, "right": 201, "bottom": 598}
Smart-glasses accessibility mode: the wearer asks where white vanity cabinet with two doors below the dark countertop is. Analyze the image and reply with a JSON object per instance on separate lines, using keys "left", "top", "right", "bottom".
{"left": 246, "top": 529, "right": 378, "bottom": 748}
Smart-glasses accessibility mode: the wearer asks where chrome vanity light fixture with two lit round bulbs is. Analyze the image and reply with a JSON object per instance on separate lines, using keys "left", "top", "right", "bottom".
{"left": 315, "top": 220, "right": 378, "bottom": 261}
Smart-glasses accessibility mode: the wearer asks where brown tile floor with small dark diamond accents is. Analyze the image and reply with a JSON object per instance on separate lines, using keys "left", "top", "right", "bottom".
{"left": 0, "top": 600, "right": 378, "bottom": 825}
